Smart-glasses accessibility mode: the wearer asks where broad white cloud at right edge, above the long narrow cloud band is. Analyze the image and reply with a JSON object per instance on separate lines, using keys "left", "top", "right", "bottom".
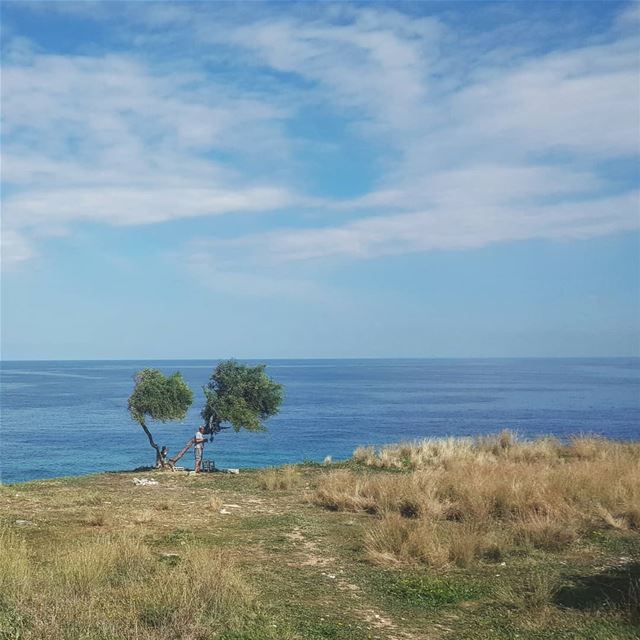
{"left": 452, "top": 38, "right": 640, "bottom": 157}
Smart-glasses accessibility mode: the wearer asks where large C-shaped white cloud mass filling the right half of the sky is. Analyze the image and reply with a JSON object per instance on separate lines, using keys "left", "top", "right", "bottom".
{"left": 201, "top": 6, "right": 640, "bottom": 261}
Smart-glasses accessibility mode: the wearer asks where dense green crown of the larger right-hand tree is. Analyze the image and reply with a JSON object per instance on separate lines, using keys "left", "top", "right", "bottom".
{"left": 202, "top": 360, "right": 282, "bottom": 431}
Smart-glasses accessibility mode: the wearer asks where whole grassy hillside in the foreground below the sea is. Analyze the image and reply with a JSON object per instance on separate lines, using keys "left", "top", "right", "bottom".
{"left": 0, "top": 433, "right": 640, "bottom": 640}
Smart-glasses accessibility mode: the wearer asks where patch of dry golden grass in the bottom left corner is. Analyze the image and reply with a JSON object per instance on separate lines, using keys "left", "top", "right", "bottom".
{"left": 0, "top": 530, "right": 254, "bottom": 640}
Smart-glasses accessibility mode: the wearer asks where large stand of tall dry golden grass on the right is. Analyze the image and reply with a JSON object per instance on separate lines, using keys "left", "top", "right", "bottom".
{"left": 313, "top": 432, "right": 640, "bottom": 566}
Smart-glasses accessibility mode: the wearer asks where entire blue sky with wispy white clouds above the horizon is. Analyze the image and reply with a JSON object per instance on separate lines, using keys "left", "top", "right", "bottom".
{"left": 1, "top": 1, "right": 640, "bottom": 360}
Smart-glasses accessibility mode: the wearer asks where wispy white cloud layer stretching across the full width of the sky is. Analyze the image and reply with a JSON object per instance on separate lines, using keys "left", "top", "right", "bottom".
{"left": 2, "top": 3, "right": 640, "bottom": 272}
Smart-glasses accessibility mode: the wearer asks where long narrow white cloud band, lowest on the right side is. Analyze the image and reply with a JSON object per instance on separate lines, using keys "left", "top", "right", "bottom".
{"left": 212, "top": 190, "right": 640, "bottom": 264}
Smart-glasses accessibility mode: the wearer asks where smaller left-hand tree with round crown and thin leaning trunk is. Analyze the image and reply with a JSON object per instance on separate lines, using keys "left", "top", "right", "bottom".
{"left": 129, "top": 369, "right": 193, "bottom": 467}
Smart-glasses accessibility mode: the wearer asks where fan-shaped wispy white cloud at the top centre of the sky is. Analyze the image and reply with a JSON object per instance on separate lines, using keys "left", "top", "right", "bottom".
{"left": 224, "top": 10, "right": 443, "bottom": 138}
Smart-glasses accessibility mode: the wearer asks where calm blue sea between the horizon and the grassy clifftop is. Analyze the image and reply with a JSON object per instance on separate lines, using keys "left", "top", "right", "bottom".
{"left": 0, "top": 358, "right": 640, "bottom": 483}
